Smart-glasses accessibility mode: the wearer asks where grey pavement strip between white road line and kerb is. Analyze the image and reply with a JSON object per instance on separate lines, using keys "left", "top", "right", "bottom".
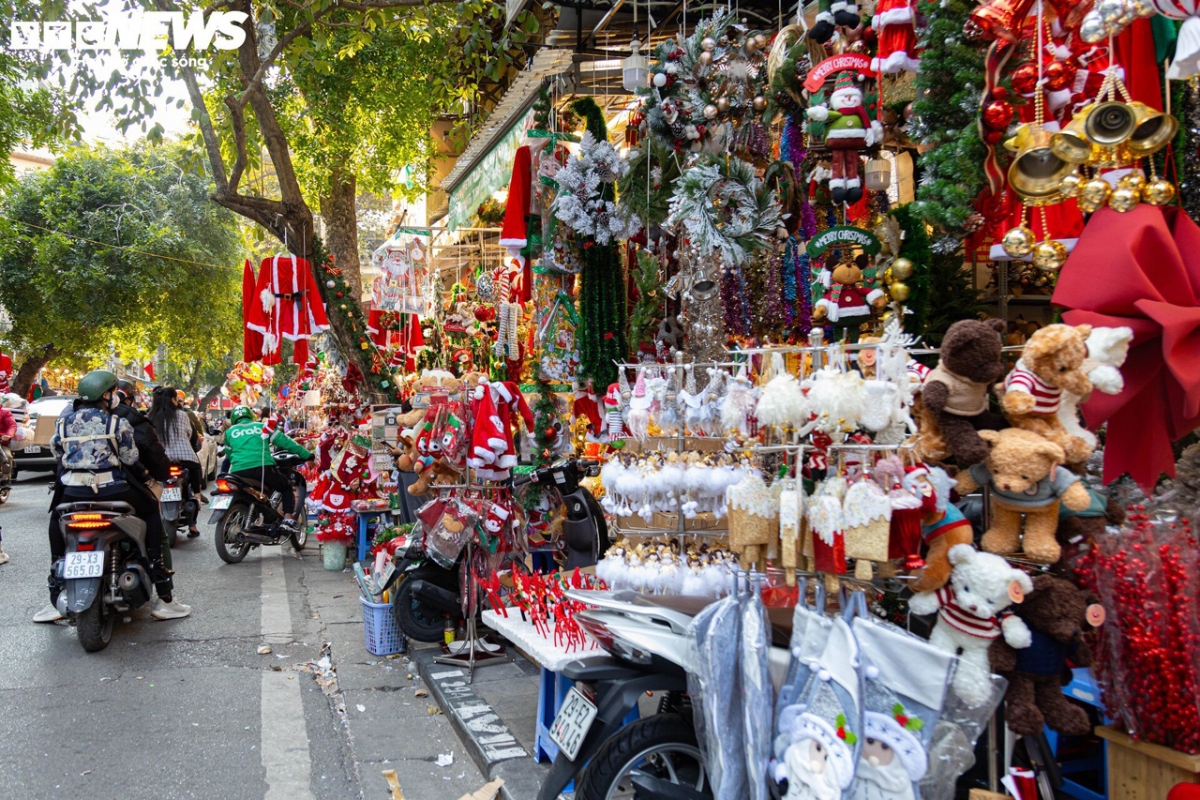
{"left": 304, "top": 558, "right": 492, "bottom": 800}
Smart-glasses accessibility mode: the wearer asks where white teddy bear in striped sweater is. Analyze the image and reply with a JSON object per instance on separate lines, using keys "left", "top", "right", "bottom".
{"left": 908, "top": 545, "right": 1033, "bottom": 708}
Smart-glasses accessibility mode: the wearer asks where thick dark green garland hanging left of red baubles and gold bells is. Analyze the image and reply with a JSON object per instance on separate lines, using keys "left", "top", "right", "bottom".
{"left": 910, "top": 0, "right": 988, "bottom": 239}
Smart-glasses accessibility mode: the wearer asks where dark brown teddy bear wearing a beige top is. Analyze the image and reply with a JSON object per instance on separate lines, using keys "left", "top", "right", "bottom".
{"left": 920, "top": 319, "right": 1004, "bottom": 467}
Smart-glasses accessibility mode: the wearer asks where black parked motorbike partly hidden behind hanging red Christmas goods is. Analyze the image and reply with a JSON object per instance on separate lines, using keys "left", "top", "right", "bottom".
{"left": 389, "top": 459, "right": 608, "bottom": 642}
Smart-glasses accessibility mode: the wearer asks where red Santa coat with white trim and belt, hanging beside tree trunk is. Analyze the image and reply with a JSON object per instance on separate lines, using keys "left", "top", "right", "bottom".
{"left": 246, "top": 254, "right": 329, "bottom": 363}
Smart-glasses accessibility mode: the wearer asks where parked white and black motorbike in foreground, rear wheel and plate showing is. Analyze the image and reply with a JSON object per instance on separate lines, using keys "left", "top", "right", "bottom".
{"left": 538, "top": 590, "right": 713, "bottom": 800}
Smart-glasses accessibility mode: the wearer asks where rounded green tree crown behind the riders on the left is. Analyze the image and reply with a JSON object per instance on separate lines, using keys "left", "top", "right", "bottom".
{"left": 0, "top": 146, "right": 241, "bottom": 383}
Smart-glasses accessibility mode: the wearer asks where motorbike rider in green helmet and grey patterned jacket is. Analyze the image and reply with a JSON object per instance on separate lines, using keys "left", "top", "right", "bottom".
{"left": 34, "top": 369, "right": 191, "bottom": 622}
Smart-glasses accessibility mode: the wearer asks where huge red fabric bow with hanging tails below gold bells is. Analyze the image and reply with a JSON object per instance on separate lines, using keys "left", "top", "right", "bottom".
{"left": 1054, "top": 205, "right": 1200, "bottom": 488}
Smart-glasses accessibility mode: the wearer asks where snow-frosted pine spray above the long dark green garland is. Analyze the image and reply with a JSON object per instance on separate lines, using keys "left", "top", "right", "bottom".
{"left": 552, "top": 132, "right": 641, "bottom": 245}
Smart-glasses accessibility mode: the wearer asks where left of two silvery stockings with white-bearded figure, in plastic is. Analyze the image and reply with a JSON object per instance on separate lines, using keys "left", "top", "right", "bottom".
{"left": 772, "top": 619, "right": 863, "bottom": 800}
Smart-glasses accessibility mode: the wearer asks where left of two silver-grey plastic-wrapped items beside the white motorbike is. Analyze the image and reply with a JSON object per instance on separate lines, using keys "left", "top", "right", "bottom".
{"left": 688, "top": 595, "right": 748, "bottom": 800}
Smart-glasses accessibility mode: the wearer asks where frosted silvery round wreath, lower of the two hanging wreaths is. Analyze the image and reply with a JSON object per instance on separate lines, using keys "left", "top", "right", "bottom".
{"left": 667, "top": 157, "right": 782, "bottom": 266}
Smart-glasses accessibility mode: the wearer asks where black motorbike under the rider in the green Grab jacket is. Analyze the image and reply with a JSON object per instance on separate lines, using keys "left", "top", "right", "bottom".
{"left": 209, "top": 451, "right": 311, "bottom": 564}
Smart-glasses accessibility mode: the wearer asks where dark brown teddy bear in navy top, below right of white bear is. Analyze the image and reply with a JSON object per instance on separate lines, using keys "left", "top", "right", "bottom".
{"left": 988, "top": 575, "right": 1100, "bottom": 736}
